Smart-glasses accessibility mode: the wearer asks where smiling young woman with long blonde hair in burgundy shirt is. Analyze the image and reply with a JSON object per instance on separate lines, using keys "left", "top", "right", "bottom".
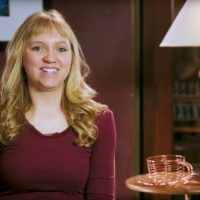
{"left": 0, "top": 10, "right": 116, "bottom": 200}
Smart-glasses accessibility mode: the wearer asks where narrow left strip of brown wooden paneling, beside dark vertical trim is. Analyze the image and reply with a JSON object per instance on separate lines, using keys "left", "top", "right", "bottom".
{"left": 142, "top": 0, "right": 155, "bottom": 167}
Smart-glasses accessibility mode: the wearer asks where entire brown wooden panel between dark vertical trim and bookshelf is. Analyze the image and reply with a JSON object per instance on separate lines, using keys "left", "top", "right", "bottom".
{"left": 143, "top": 0, "right": 172, "bottom": 200}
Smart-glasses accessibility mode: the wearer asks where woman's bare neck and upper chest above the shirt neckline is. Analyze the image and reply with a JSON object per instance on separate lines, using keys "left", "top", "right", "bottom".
{"left": 26, "top": 86, "right": 68, "bottom": 134}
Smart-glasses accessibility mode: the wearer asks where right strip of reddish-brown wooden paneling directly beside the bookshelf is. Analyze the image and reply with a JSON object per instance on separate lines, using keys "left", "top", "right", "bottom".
{"left": 155, "top": 0, "right": 173, "bottom": 154}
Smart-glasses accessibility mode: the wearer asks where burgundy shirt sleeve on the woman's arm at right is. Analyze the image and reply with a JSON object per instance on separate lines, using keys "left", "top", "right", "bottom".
{"left": 86, "top": 110, "right": 116, "bottom": 200}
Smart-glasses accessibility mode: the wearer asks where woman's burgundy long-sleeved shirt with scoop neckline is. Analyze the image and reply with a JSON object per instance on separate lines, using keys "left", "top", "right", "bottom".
{"left": 0, "top": 110, "right": 116, "bottom": 200}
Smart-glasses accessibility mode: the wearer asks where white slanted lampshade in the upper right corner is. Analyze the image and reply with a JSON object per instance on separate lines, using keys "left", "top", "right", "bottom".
{"left": 160, "top": 0, "right": 200, "bottom": 47}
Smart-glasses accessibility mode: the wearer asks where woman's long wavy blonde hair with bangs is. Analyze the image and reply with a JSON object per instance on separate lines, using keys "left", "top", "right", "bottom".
{"left": 0, "top": 10, "right": 106, "bottom": 147}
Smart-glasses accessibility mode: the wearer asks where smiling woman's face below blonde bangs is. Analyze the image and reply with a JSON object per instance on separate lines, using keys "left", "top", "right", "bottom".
{"left": 22, "top": 29, "right": 72, "bottom": 91}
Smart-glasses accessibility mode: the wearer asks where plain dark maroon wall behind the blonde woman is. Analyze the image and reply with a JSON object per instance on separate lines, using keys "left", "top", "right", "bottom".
{"left": 0, "top": 0, "right": 137, "bottom": 200}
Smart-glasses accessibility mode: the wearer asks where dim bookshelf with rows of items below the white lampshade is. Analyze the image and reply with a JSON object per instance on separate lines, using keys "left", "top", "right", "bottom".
{"left": 172, "top": 48, "right": 200, "bottom": 165}
